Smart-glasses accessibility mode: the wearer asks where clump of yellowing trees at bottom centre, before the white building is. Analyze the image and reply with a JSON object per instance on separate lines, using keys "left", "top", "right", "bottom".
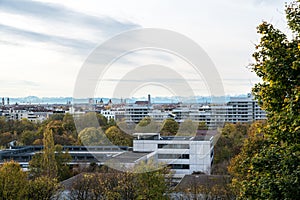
{"left": 67, "top": 160, "right": 172, "bottom": 200}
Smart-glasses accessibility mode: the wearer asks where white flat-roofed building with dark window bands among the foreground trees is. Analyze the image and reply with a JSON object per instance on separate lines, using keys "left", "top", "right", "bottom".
{"left": 133, "top": 133, "right": 214, "bottom": 178}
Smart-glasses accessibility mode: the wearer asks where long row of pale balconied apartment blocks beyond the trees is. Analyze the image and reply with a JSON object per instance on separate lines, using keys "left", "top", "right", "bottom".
{"left": 115, "top": 94, "right": 267, "bottom": 128}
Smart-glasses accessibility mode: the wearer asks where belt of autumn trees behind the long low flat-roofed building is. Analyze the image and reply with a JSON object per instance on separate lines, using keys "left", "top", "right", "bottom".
{"left": 0, "top": 112, "right": 207, "bottom": 148}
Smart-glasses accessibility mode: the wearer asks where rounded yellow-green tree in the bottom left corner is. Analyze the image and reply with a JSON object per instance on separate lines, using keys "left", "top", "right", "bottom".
{"left": 0, "top": 161, "right": 27, "bottom": 199}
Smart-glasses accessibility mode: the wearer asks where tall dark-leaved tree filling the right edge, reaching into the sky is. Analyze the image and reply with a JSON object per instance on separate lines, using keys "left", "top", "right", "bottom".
{"left": 230, "top": 0, "right": 300, "bottom": 199}
